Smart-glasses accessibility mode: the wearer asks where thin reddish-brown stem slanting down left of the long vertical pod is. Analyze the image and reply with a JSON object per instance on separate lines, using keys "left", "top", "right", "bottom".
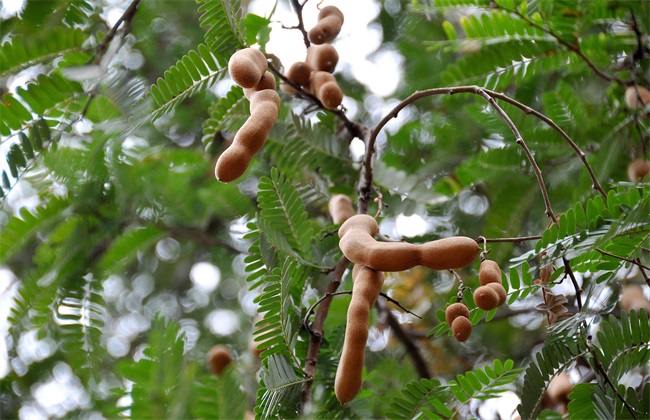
{"left": 302, "top": 256, "right": 349, "bottom": 406}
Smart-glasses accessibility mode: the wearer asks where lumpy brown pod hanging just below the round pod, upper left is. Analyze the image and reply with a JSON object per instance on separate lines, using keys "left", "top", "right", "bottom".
{"left": 214, "top": 89, "right": 280, "bottom": 182}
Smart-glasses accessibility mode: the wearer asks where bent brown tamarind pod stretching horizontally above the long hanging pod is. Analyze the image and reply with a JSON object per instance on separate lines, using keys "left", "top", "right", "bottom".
{"left": 339, "top": 214, "right": 479, "bottom": 271}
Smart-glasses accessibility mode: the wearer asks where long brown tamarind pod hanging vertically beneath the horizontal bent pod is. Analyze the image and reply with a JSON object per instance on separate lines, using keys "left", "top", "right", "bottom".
{"left": 334, "top": 266, "right": 384, "bottom": 404}
